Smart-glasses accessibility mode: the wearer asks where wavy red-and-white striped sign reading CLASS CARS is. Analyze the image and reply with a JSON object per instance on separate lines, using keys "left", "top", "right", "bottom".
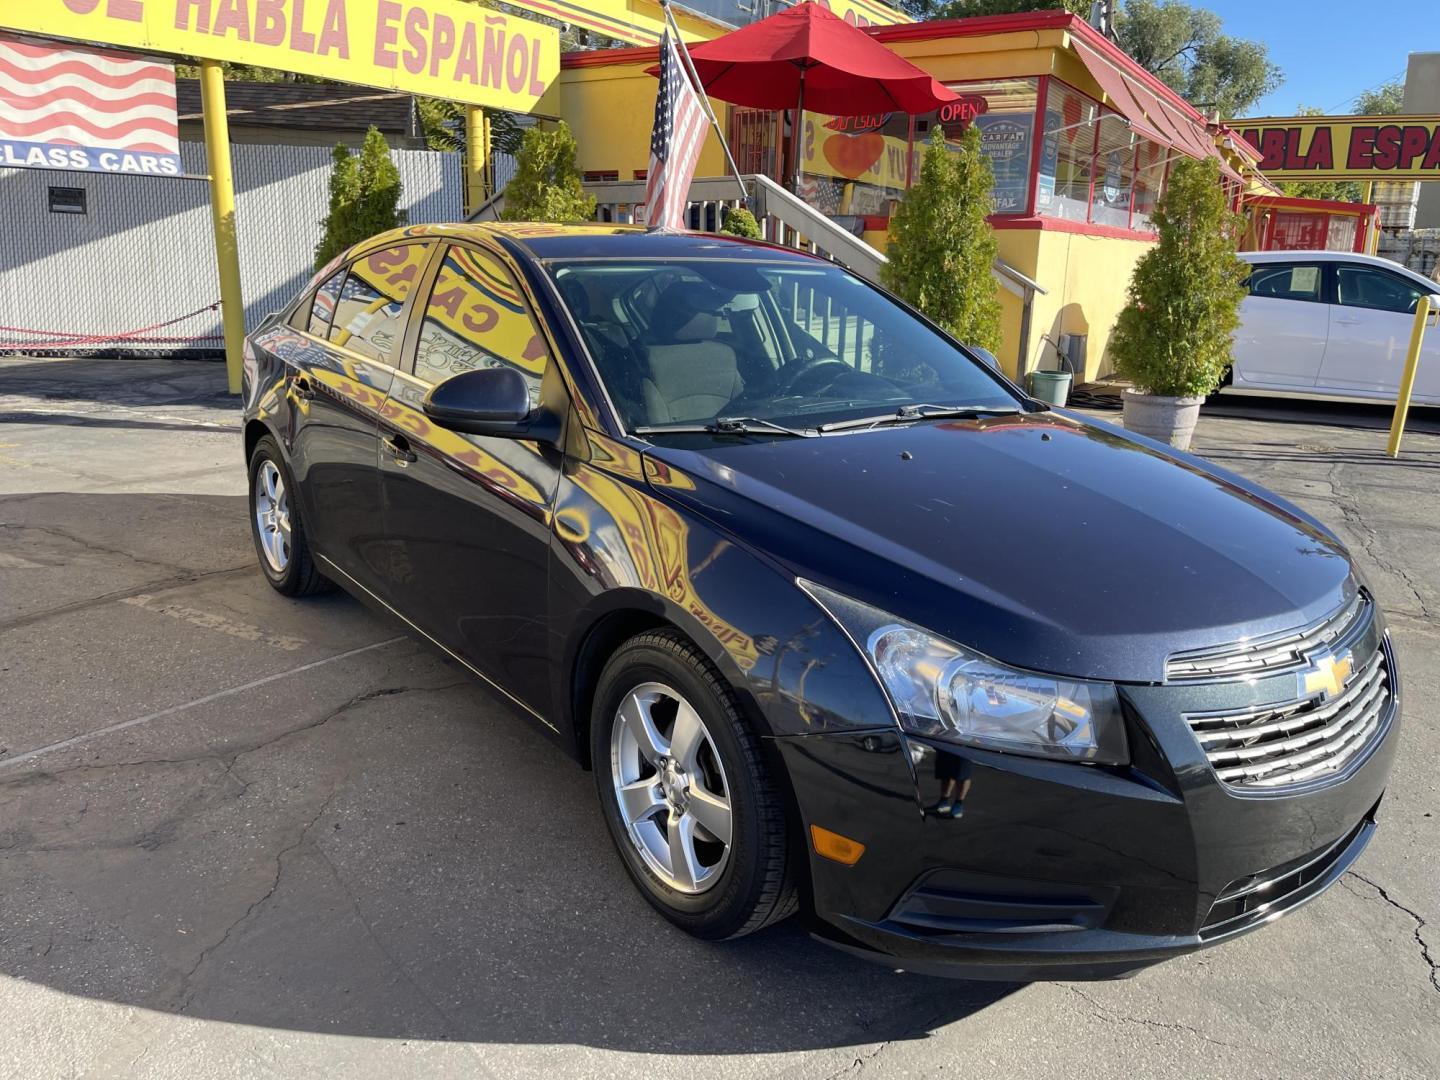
{"left": 0, "top": 33, "right": 184, "bottom": 176}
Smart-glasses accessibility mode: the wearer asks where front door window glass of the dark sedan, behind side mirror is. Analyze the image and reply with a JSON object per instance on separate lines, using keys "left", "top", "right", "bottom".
{"left": 415, "top": 246, "right": 547, "bottom": 405}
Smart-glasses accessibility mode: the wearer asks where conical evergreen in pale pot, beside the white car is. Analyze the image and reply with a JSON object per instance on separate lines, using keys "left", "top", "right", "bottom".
{"left": 1110, "top": 158, "right": 1247, "bottom": 449}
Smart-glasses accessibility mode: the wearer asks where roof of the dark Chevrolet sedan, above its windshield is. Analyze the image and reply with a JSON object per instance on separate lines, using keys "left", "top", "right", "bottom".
{"left": 355, "top": 222, "right": 816, "bottom": 264}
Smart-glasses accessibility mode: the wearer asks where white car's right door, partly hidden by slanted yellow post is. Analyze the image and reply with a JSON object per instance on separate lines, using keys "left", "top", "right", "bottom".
{"left": 1318, "top": 262, "right": 1440, "bottom": 402}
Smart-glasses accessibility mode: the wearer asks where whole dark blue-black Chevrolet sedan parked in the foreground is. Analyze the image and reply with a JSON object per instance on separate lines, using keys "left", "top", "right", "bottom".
{"left": 245, "top": 225, "right": 1400, "bottom": 979}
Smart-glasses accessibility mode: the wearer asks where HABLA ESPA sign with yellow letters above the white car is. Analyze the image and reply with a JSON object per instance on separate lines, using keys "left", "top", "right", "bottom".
{"left": 1231, "top": 117, "right": 1440, "bottom": 180}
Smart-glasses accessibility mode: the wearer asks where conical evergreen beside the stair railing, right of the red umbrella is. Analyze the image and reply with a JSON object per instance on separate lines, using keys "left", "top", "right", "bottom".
{"left": 880, "top": 125, "right": 999, "bottom": 351}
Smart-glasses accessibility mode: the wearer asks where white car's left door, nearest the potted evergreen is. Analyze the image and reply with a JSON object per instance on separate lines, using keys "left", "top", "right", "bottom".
{"left": 1233, "top": 261, "right": 1331, "bottom": 389}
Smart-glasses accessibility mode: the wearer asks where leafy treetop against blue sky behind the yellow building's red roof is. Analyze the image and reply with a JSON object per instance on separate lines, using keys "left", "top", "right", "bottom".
{"left": 1115, "top": 0, "right": 1282, "bottom": 117}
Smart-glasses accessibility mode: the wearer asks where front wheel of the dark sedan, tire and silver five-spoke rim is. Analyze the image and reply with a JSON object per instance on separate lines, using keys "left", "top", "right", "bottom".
{"left": 590, "top": 631, "right": 798, "bottom": 940}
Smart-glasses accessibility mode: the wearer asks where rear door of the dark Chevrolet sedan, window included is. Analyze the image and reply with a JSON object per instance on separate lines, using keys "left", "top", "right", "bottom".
{"left": 291, "top": 243, "right": 428, "bottom": 586}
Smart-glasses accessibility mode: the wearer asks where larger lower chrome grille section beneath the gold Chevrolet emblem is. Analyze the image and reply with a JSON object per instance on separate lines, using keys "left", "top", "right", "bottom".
{"left": 1185, "top": 648, "right": 1391, "bottom": 789}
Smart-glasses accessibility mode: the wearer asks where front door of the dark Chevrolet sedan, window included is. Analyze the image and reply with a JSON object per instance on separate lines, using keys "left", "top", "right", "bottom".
{"left": 380, "top": 245, "right": 567, "bottom": 716}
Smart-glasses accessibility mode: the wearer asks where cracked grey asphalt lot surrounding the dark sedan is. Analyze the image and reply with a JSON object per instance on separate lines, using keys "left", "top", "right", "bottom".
{"left": 0, "top": 357, "right": 1440, "bottom": 1080}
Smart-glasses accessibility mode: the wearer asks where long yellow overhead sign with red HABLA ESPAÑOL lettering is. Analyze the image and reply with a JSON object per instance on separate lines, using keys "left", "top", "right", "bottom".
{"left": 0, "top": 0, "right": 560, "bottom": 112}
